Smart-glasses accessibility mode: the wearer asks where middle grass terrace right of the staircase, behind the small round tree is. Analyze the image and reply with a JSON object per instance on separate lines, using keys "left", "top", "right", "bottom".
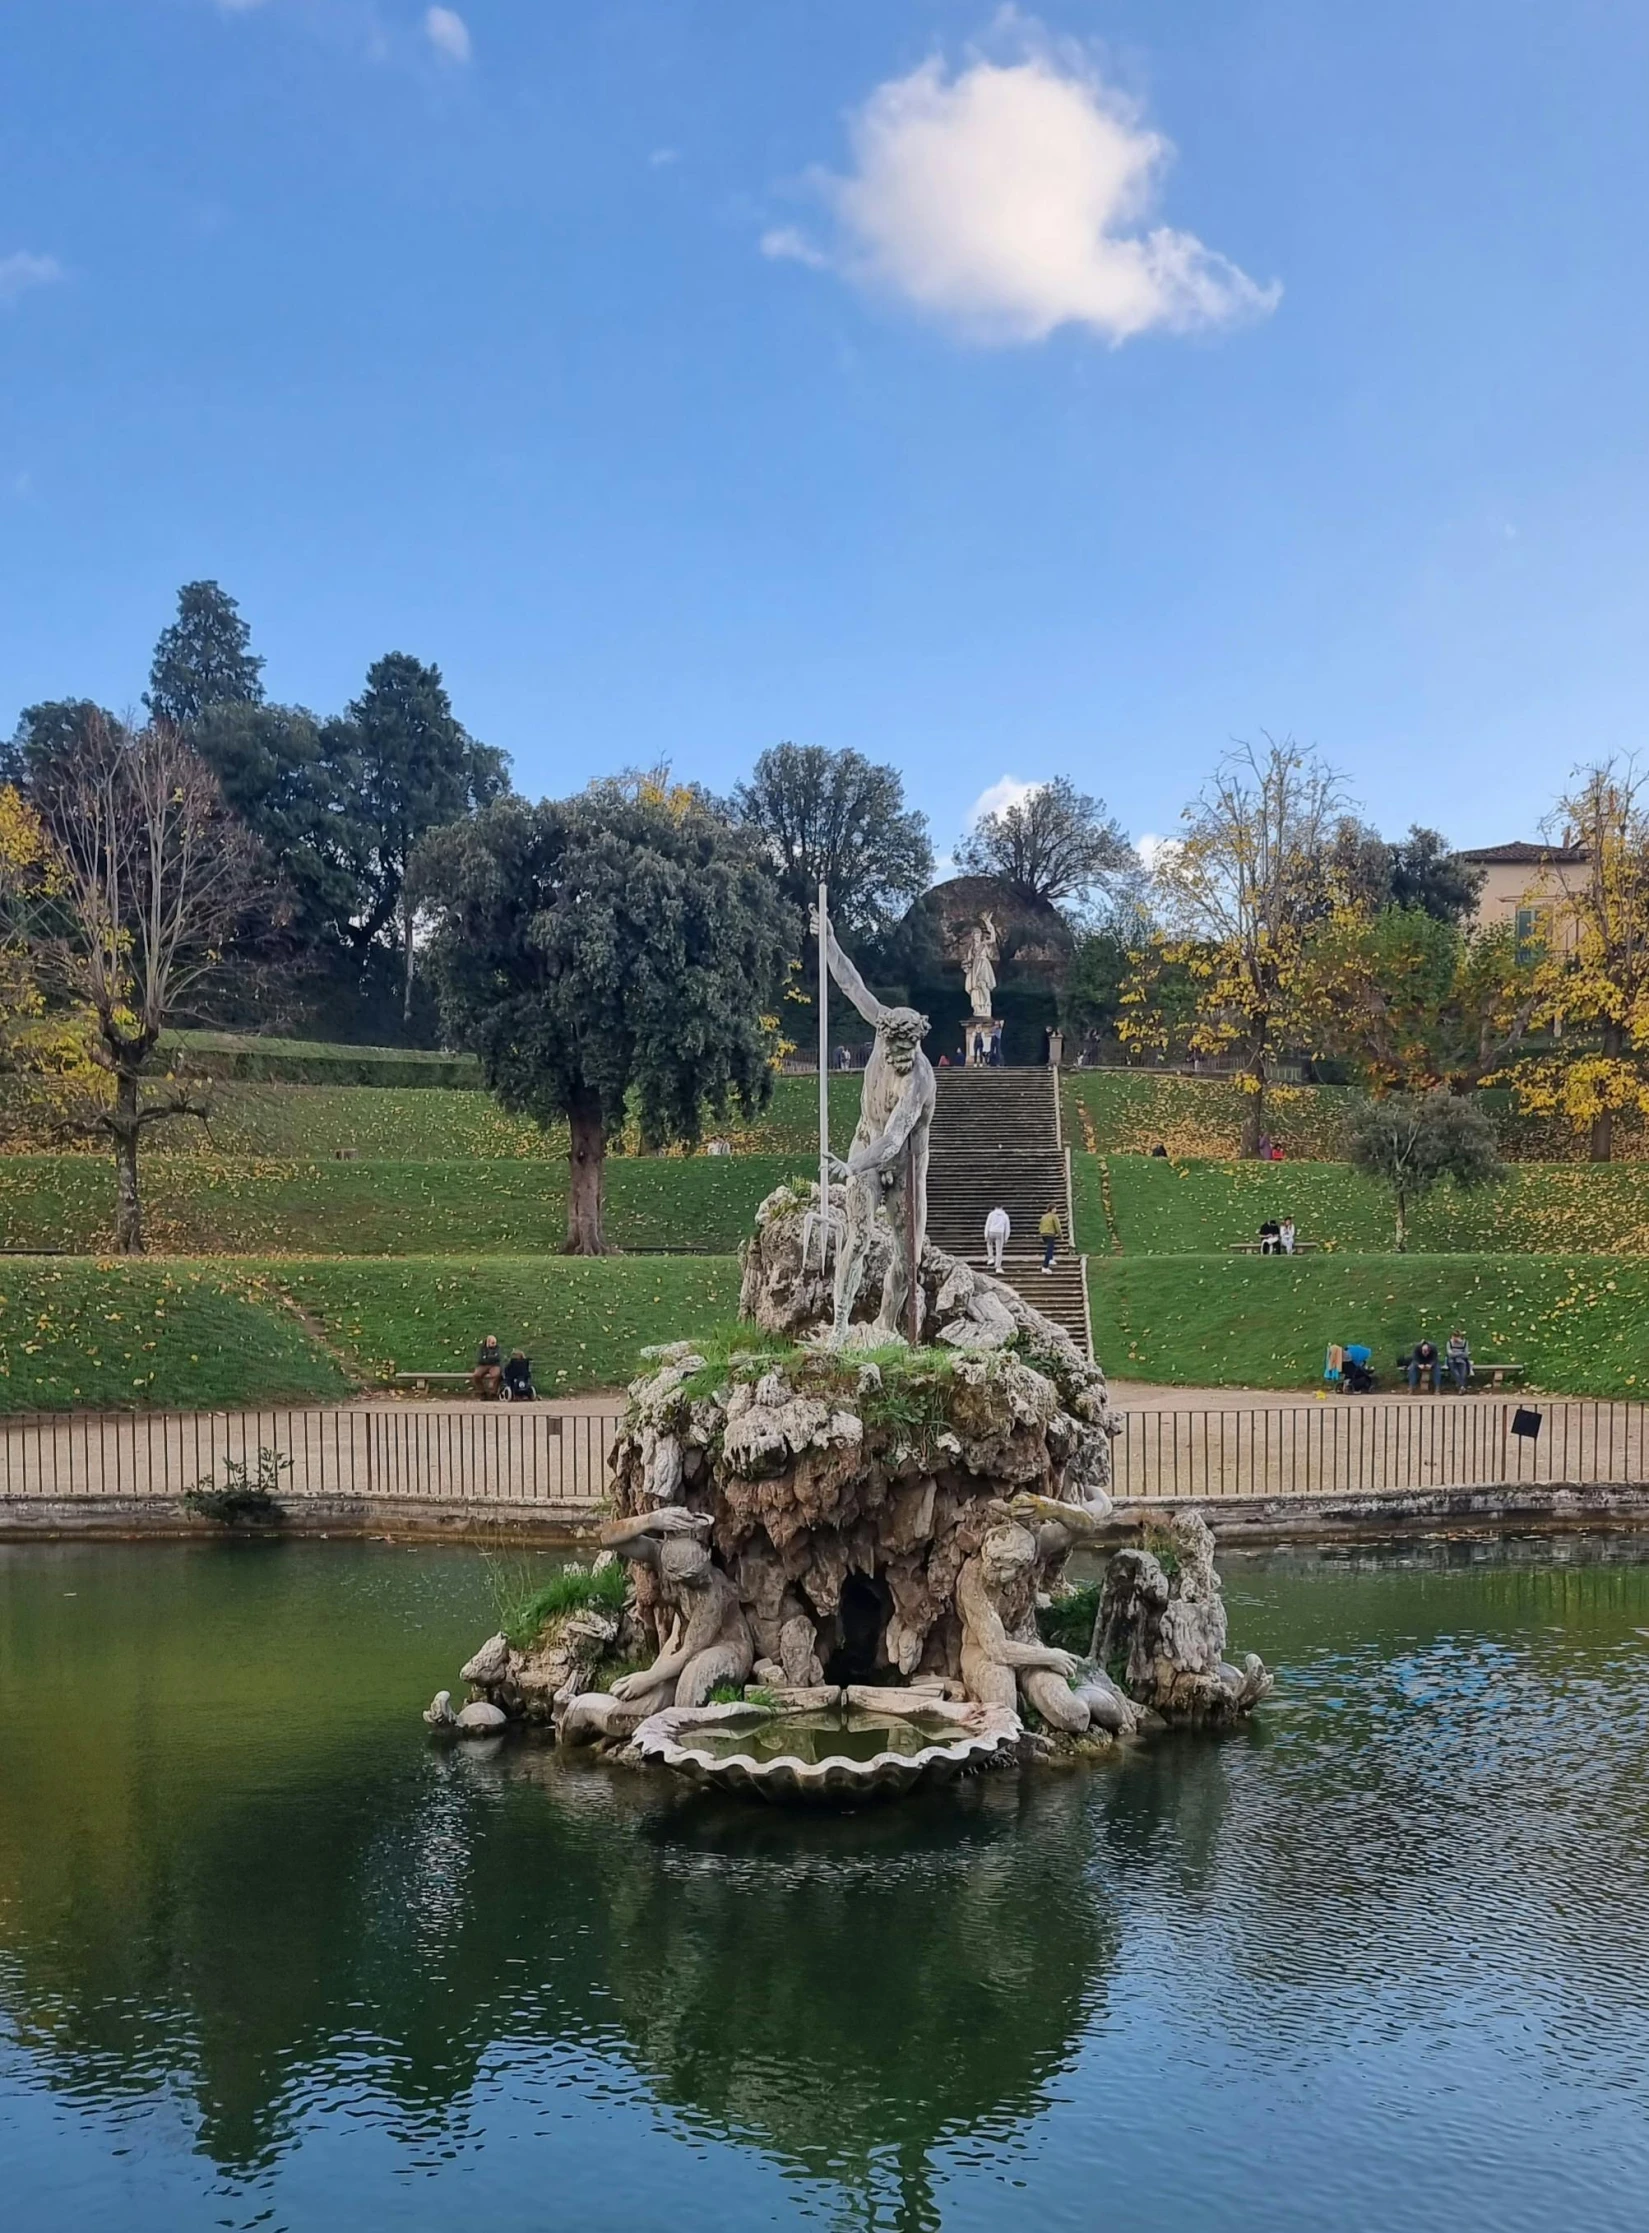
{"left": 1073, "top": 1154, "right": 1649, "bottom": 1257}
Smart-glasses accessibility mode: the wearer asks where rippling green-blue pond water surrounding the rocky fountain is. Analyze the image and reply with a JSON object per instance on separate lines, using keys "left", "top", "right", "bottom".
{"left": 0, "top": 1539, "right": 1649, "bottom": 2233}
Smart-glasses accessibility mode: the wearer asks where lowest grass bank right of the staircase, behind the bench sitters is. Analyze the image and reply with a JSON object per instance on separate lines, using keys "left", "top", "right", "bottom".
{"left": 1088, "top": 1255, "right": 1649, "bottom": 1396}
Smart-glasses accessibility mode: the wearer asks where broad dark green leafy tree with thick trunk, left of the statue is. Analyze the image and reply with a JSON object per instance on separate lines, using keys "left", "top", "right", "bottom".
{"left": 418, "top": 782, "right": 802, "bottom": 1255}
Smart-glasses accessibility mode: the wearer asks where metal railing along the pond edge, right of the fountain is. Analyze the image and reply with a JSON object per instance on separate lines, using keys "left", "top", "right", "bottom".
{"left": 1113, "top": 1396, "right": 1649, "bottom": 1503}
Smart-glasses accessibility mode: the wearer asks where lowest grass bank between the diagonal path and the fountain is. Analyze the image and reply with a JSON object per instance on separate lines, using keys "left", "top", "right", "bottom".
{"left": 266, "top": 1257, "right": 740, "bottom": 1396}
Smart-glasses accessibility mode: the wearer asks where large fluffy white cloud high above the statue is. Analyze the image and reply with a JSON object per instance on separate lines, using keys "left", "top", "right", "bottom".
{"left": 762, "top": 51, "right": 1283, "bottom": 344}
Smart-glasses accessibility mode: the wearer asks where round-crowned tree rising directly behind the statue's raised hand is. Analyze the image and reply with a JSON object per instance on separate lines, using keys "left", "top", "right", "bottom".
{"left": 733, "top": 744, "right": 934, "bottom": 938}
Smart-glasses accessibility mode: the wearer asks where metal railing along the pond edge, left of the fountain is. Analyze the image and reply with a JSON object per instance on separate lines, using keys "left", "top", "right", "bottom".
{"left": 0, "top": 1405, "right": 619, "bottom": 1512}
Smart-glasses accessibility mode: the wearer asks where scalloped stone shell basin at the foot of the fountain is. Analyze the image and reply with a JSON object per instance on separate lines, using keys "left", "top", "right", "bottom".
{"left": 630, "top": 1686, "right": 1023, "bottom": 1804}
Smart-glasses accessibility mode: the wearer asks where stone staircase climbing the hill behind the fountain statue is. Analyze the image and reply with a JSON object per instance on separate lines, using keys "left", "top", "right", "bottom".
{"left": 927, "top": 1070, "right": 1088, "bottom": 1351}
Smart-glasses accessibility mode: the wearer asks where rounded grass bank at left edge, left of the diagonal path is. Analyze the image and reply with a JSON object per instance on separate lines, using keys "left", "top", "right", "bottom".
{"left": 0, "top": 1264, "right": 351, "bottom": 1411}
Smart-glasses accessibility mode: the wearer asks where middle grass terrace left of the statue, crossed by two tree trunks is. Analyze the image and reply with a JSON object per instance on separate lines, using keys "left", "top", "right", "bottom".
{"left": 0, "top": 1152, "right": 804, "bottom": 1257}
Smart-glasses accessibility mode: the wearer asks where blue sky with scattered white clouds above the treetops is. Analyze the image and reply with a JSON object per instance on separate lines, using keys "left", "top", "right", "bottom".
{"left": 0, "top": 0, "right": 1649, "bottom": 849}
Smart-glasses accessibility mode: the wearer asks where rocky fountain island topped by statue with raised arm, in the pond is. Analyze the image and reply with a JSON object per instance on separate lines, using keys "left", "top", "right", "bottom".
{"left": 431, "top": 915, "right": 1269, "bottom": 1800}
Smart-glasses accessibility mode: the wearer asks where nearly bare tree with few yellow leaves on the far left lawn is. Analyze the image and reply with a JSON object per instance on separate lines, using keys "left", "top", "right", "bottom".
{"left": 34, "top": 717, "right": 257, "bottom": 1255}
